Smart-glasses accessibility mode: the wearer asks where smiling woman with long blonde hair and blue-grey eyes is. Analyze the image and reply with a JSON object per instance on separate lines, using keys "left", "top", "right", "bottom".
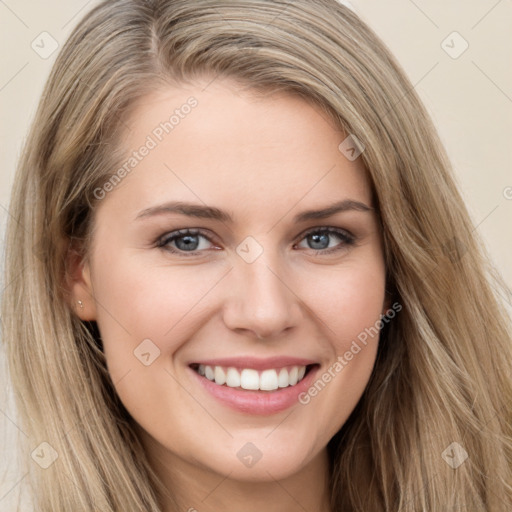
{"left": 3, "top": 0, "right": 512, "bottom": 512}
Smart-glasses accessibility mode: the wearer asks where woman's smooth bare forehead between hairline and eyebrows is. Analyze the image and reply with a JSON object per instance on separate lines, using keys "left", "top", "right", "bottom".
{"left": 102, "top": 79, "right": 371, "bottom": 220}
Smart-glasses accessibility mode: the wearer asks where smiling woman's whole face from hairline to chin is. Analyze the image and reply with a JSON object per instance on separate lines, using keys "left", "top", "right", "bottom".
{"left": 73, "top": 79, "right": 385, "bottom": 481}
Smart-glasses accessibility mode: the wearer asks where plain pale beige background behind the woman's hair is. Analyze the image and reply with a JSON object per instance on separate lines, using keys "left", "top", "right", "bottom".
{"left": 0, "top": 0, "right": 512, "bottom": 511}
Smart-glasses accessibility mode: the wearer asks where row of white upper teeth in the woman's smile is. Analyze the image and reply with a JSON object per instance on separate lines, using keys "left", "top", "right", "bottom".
{"left": 197, "top": 364, "right": 306, "bottom": 391}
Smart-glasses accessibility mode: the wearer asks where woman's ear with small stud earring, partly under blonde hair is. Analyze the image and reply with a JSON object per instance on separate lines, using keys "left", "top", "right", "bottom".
{"left": 65, "top": 247, "right": 96, "bottom": 321}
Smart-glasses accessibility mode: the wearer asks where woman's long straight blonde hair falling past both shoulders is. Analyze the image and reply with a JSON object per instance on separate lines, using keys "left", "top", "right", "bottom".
{"left": 2, "top": 0, "right": 512, "bottom": 512}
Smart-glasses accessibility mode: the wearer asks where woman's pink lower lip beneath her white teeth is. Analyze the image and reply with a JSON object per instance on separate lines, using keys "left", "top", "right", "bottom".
{"left": 189, "top": 365, "right": 320, "bottom": 416}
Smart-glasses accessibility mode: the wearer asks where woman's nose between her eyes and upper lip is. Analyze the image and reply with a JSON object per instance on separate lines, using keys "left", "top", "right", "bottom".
{"left": 223, "top": 253, "right": 303, "bottom": 339}
